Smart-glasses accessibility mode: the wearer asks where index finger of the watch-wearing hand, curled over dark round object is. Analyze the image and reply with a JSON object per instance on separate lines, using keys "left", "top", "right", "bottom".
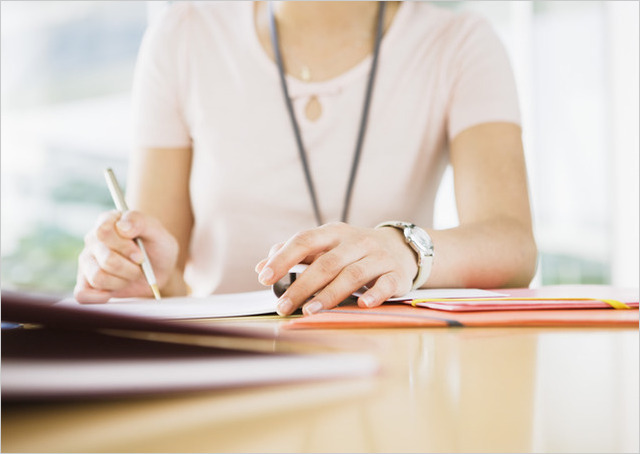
{"left": 258, "top": 226, "right": 339, "bottom": 285}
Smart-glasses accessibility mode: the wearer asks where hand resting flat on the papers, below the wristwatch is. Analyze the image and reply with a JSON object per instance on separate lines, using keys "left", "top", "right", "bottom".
{"left": 256, "top": 222, "right": 418, "bottom": 315}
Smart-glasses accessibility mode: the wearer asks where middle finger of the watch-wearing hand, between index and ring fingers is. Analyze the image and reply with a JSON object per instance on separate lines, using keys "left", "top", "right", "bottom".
{"left": 278, "top": 245, "right": 366, "bottom": 315}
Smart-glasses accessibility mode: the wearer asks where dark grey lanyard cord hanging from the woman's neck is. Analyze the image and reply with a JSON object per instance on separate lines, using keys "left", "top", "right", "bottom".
{"left": 268, "top": 1, "right": 386, "bottom": 226}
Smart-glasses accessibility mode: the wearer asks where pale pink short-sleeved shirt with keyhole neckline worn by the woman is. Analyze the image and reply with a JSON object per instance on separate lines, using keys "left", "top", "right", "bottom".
{"left": 134, "top": 2, "right": 520, "bottom": 295}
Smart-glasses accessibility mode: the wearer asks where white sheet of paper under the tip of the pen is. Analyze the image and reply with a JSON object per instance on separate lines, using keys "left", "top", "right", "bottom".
{"left": 58, "top": 290, "right": 277, "bottom": 320}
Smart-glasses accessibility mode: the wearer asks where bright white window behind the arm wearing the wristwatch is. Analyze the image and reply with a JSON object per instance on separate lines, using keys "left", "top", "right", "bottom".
{"left": 437, "top": 1, "right": 640, "bottom": 287}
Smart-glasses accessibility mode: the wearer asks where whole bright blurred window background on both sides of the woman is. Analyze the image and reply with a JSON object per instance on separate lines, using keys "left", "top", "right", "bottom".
{"left": 0, "top": 1, "right": 640, "bottom": 294}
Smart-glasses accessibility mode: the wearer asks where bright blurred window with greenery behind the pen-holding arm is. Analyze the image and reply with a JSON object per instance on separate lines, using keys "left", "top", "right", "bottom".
{"left": 1, "top": 1, "right": 147, "bottom": 293}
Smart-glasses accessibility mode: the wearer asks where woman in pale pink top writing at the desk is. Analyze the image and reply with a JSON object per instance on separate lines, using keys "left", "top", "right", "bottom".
{"left": 75, "top": 2, "right": 536, "bottom": 315}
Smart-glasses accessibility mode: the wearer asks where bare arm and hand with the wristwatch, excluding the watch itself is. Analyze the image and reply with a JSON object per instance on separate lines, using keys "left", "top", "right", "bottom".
{"left": 256, "top": 119, "right": 536, "bottom": 314}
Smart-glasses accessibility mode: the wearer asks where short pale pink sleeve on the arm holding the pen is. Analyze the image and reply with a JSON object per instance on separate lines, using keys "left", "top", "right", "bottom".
{"left": 132, "top": 2, "right": 191, "bottom": 148}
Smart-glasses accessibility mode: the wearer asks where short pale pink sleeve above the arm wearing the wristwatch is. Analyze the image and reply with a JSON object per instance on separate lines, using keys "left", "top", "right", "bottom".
{"left": 448, "top": 16, "right": 520, "bottom": 139}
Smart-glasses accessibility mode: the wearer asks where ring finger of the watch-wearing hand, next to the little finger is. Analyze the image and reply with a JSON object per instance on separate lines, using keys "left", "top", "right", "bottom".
{"left": 302, "top": 256, "right": 390, "bottom": 315}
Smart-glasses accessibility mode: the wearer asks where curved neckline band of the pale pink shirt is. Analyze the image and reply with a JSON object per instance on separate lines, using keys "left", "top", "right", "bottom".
{"left": 242, "top": 2, "right": 413, "bottom": 98}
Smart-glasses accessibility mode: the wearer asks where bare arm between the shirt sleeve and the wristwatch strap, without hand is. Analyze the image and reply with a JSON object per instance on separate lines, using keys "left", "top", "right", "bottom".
{"left": 426, "top": 123, "right": 537, "bottom": 288}
